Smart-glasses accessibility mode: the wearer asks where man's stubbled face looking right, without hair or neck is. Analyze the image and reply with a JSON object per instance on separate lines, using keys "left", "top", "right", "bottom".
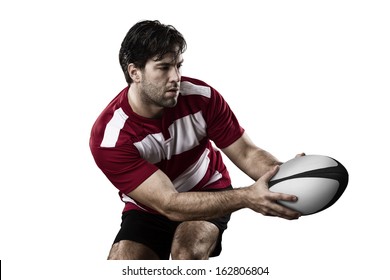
{"left": 140, "top": 53, "right": 183, "bottom": 108}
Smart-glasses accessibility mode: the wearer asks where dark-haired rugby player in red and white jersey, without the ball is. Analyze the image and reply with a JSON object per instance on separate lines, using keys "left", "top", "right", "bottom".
{"left": 90, "top": 21, "right": 300, "bottom": 259}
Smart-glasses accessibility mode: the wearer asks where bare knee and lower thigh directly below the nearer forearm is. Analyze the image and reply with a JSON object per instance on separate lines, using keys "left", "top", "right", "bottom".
{"left": 171, "top": 221, "right": 220, "bottom": 259}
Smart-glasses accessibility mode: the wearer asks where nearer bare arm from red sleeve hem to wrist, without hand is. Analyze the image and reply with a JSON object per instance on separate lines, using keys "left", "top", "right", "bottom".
{"left": 128, "top": 170, "right": 254, "bottom": 221}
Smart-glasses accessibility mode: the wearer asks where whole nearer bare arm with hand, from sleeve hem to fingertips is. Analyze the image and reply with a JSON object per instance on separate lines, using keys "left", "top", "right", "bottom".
{"left": 128, "top": 168, "right": 297, "bottom": 221}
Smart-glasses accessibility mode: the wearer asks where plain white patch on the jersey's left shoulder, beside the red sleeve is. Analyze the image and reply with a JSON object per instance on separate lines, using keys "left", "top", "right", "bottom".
{"left": 100, "top": 108, "right": 129, "bottom": 148}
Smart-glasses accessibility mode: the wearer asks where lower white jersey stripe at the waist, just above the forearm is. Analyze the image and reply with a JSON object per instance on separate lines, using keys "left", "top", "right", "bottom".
{"left": 172, "top": 149, "right": 210, "bottom": 192}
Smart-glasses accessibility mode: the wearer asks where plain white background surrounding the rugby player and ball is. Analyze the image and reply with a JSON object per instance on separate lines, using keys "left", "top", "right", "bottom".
{"left": 0, "top": 0, "right": 390, "bottom": 279}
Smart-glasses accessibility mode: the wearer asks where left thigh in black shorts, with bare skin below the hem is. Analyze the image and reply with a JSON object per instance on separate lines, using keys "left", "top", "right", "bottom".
{"left": 109, "top": 210, "right": 178, "bottom": 259}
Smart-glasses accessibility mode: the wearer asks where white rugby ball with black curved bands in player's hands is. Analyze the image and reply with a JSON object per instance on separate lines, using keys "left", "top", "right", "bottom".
{"left": 268, "top": 155, "right": 348, "bottom": 215}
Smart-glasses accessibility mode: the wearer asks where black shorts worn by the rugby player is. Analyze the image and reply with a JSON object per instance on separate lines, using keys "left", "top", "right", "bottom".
{"left": 114, "top": 187, "right": 230, "bottom": 260}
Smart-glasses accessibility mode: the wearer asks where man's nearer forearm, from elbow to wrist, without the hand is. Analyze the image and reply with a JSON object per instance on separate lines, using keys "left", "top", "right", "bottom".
{"left": 163, "top": 188, "right": 250, "bottom": 221}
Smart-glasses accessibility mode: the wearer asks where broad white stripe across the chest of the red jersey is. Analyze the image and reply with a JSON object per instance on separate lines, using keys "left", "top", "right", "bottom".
{"left": 134, "top": 111, "right": 207, "bottom": 164}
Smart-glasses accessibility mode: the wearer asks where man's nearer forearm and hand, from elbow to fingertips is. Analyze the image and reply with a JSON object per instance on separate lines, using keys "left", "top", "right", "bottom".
{"left": 162, "top": 166, "right": 300, "bottom": 221}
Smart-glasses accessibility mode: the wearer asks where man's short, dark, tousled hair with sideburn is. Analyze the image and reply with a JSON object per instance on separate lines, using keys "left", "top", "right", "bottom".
{"left": 119, "top": 20, "right": 187, "bottom": 84}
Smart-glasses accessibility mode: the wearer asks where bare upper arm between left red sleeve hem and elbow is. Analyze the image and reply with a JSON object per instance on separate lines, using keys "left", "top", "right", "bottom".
{"left": 127, "top": 170, "right": 178, "bottom": 214}
